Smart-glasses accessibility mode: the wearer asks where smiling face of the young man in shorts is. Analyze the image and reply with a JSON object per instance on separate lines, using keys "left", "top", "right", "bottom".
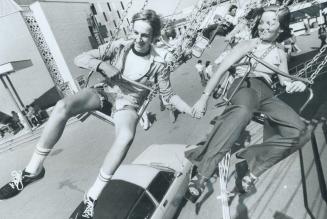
{"left": 132, "top": 20, "right": 153, "bottom": 53}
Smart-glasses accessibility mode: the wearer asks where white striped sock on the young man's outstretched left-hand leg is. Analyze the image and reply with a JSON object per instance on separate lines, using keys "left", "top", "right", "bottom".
{"left": 25, "top": 145, "right": 51, "bottom": 175}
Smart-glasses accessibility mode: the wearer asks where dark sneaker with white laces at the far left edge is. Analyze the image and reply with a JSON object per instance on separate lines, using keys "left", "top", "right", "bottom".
{"left": 0, "top": 167, "right": 45, "bottom": 200}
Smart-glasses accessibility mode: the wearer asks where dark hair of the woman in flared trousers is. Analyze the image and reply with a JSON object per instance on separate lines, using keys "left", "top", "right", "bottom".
{"left": 252, "top": 5, "right": 292, "bottom": 43}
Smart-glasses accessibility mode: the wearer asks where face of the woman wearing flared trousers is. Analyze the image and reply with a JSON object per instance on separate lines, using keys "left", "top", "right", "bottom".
{"left": 258, "top": 11, "right": 281, "bottom": 42}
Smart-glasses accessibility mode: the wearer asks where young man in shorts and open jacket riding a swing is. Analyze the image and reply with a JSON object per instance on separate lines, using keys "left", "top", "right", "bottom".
{"left": 0, "top": 10, "right": 191, "bottom": 219}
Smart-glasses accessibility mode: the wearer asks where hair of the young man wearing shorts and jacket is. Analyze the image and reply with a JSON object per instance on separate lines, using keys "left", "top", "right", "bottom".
{"left": 132, "top": 9, "right": 161, "bottom": 38}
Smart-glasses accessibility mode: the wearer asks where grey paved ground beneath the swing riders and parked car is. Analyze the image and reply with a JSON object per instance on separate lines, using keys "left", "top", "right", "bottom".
{"left": 0, "top": 33, "right": 327, "bottom": 219}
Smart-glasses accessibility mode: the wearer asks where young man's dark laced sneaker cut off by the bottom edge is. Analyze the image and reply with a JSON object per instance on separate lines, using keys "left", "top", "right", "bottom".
{"left": 69, "top": 195, "right": 96, "bottom": 219}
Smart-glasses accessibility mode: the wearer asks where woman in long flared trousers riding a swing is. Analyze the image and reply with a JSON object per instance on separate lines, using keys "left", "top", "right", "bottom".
{"left": 185, "top": 5, "right": 306, "bottom": 201}
